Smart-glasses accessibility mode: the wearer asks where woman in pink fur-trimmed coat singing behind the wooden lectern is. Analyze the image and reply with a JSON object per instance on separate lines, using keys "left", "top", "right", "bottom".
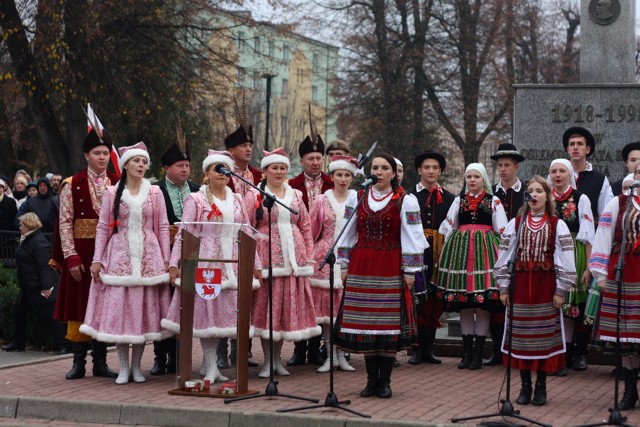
{"left": 161, "top": 150, "right": 260, "bottom": 382}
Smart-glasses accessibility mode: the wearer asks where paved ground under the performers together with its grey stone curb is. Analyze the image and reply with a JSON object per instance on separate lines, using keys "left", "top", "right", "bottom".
{"left": 0, "top": 339, "right": 640, "bottom": 426}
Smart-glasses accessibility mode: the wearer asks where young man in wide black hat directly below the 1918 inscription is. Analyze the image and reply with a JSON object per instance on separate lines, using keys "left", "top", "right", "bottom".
{"left": 562, "top": 126, "right": 613, "bottom": 371}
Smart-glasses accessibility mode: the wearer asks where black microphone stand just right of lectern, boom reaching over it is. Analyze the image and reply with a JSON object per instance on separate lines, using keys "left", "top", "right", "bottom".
{"left": 222, "top": 167, "right": 319, "bottom": 403}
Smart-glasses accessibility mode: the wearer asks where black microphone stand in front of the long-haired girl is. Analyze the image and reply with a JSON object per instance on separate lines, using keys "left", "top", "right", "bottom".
{"left": 451, "top": 193, "right": 551, "bottom": 427}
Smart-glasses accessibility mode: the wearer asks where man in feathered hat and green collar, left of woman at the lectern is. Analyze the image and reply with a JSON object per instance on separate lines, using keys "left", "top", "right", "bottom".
{"left": 149, "top": 119, "right": 200, "bottom": 375}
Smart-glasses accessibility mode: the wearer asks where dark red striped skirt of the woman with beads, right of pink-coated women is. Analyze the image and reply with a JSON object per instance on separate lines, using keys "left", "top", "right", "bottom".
{"left": 335, "top": 247, "right": 415, "bottom": 353}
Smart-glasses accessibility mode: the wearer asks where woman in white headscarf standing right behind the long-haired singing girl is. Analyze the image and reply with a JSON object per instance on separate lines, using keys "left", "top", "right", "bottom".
{"left": 547, "top": 159, "right": 596, "bottom": 377}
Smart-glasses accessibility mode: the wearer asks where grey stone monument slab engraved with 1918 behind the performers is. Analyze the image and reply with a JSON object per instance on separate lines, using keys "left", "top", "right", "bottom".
{"left": 513, "top": 84, "right": 640, "bottom": 181}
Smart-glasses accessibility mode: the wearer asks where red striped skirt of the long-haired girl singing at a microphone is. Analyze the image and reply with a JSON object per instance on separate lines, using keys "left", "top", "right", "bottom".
{"left": 502, "top": 269, "right": 566, "bottom": 372}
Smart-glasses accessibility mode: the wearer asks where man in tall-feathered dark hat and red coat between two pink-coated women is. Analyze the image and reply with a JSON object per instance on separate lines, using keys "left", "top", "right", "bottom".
{"left": 287, "top": 106, "right": 333, "bottom": 366}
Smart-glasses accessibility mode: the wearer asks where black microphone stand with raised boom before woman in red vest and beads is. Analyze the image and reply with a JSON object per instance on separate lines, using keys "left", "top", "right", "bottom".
{"left": 276, "top": 182, "right": 373, "bottom": 418}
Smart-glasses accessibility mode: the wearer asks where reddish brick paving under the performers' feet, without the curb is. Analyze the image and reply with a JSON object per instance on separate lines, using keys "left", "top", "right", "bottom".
{"left": 0, "top": 340, "right": 640, "bottom": 426}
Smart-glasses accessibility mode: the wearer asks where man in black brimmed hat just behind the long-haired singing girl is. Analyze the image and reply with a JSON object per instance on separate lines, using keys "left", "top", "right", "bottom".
{"left": 484, "top": 143, "right": 525, "bottom": 366}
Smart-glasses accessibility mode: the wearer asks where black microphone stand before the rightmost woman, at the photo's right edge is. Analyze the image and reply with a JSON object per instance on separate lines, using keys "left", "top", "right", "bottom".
{"left": 581, "top": 191, "right": 637, "bottom": 427}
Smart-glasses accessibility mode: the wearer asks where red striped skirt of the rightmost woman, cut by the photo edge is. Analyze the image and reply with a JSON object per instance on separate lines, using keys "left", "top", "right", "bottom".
{"left": 595, "top": 253, "right": 640, "bottom": 356}
